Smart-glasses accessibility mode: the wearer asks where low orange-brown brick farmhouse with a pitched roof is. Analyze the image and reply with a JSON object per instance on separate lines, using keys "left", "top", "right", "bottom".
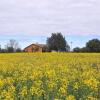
{"left": 24, "top": 43, "right": 45, "bottom": 52}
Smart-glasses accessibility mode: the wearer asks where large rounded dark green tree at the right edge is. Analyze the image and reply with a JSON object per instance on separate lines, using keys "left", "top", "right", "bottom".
{"left": 86, "top": 39, "right": 100, "bottom": 52}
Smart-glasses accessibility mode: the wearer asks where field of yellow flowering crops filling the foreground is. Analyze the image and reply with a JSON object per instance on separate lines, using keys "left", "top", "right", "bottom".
{"left": 0, "top": 53, "right": 100, "bottom": 100}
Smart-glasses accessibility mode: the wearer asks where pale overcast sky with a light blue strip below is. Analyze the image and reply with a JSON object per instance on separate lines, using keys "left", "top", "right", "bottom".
{"left": 0, "top": 0, "right": 100, "bottom": 46}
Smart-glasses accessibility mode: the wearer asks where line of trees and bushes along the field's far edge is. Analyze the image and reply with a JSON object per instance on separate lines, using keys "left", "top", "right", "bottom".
{"left": 0, "top": 33, "right": 100, "bottom": 53}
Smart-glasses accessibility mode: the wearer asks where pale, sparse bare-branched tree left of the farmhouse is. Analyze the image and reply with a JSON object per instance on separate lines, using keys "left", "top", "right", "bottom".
{"left": 6, "top": 39, "right": 19, "bottom": 52}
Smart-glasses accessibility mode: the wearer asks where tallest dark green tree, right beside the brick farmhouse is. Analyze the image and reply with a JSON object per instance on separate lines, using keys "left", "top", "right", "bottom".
{"left": 47, "top": 33, "right": 68, "bottom": 51}
